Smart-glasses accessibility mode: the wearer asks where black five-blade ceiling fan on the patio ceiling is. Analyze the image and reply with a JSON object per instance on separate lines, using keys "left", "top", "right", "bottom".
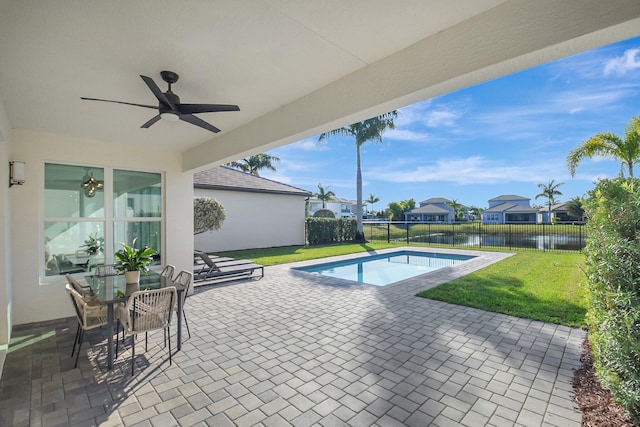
{"left": 81, "top": 71, "right": 240, "bottom": 133}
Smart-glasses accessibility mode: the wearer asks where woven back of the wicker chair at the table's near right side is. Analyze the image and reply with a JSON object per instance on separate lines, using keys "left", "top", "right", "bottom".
{"left": 126, "top": 286, "right": 177, "bottom": 335}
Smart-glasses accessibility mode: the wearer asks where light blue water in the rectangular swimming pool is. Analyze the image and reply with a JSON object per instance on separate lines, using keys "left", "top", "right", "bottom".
{"left": 296, "top": 251, "right": 474, "bottom": 286}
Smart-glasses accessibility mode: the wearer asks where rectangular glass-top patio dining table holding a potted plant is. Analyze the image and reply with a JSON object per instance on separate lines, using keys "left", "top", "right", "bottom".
{"left": 85, "top": 271, "right": 187, "bottom": 370}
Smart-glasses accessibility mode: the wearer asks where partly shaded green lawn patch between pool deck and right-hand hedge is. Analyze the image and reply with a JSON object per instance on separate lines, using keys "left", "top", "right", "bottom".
{"left": 418, "top": 252, "right": 588, "bottom": 327}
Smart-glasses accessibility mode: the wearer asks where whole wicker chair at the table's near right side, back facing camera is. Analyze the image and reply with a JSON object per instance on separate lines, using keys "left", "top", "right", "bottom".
{"left": 116, "top": 286, "right": 177, "bottom": 376}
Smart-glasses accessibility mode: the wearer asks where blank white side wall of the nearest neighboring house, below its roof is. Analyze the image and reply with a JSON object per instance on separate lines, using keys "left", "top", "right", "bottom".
{"left": 194, "top": 188, "right": 305, "bottom": 252}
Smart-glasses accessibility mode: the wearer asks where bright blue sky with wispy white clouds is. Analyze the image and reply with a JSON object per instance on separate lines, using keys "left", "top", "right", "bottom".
{"left": 261, "top": 37, "right": 640, "bottom": 210}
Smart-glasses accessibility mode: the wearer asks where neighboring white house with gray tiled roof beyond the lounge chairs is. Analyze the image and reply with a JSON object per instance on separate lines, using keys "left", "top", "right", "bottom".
{"left": 193, "top": 166, "right": 311, "bottom": 252}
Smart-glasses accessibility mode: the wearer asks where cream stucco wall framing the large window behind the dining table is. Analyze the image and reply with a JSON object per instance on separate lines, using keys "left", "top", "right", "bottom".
{"left": 9, "top": 129, "right": 193, "bottom": 325}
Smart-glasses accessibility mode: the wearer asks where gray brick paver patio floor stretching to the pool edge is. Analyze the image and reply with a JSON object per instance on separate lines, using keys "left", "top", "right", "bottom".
{"left": 0, "top": 248, "right": 584, "bottom": 426}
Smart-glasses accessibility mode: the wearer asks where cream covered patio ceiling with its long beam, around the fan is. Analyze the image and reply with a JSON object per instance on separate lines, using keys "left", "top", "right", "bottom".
{"left": 0, "top": 0, "right": 640, "bottom": 171}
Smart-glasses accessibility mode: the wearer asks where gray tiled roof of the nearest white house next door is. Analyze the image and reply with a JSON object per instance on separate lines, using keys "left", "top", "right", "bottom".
{"left": 193, "top": 166, "right": 311, "bottom": 197}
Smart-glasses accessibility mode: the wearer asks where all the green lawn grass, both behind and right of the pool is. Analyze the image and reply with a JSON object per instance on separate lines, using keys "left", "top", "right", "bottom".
{"left": 217, "top": 242, "right": 587, "bottom": 327}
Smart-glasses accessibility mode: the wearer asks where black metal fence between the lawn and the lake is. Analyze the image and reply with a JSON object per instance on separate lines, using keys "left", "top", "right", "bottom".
{"left": 363, "top": 221, "right": 587, "bottom": 251}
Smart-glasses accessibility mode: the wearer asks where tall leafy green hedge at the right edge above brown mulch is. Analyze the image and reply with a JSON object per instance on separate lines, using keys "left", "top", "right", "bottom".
{"left": 585, "top": 178, "right": 640, "bottom": 425}
